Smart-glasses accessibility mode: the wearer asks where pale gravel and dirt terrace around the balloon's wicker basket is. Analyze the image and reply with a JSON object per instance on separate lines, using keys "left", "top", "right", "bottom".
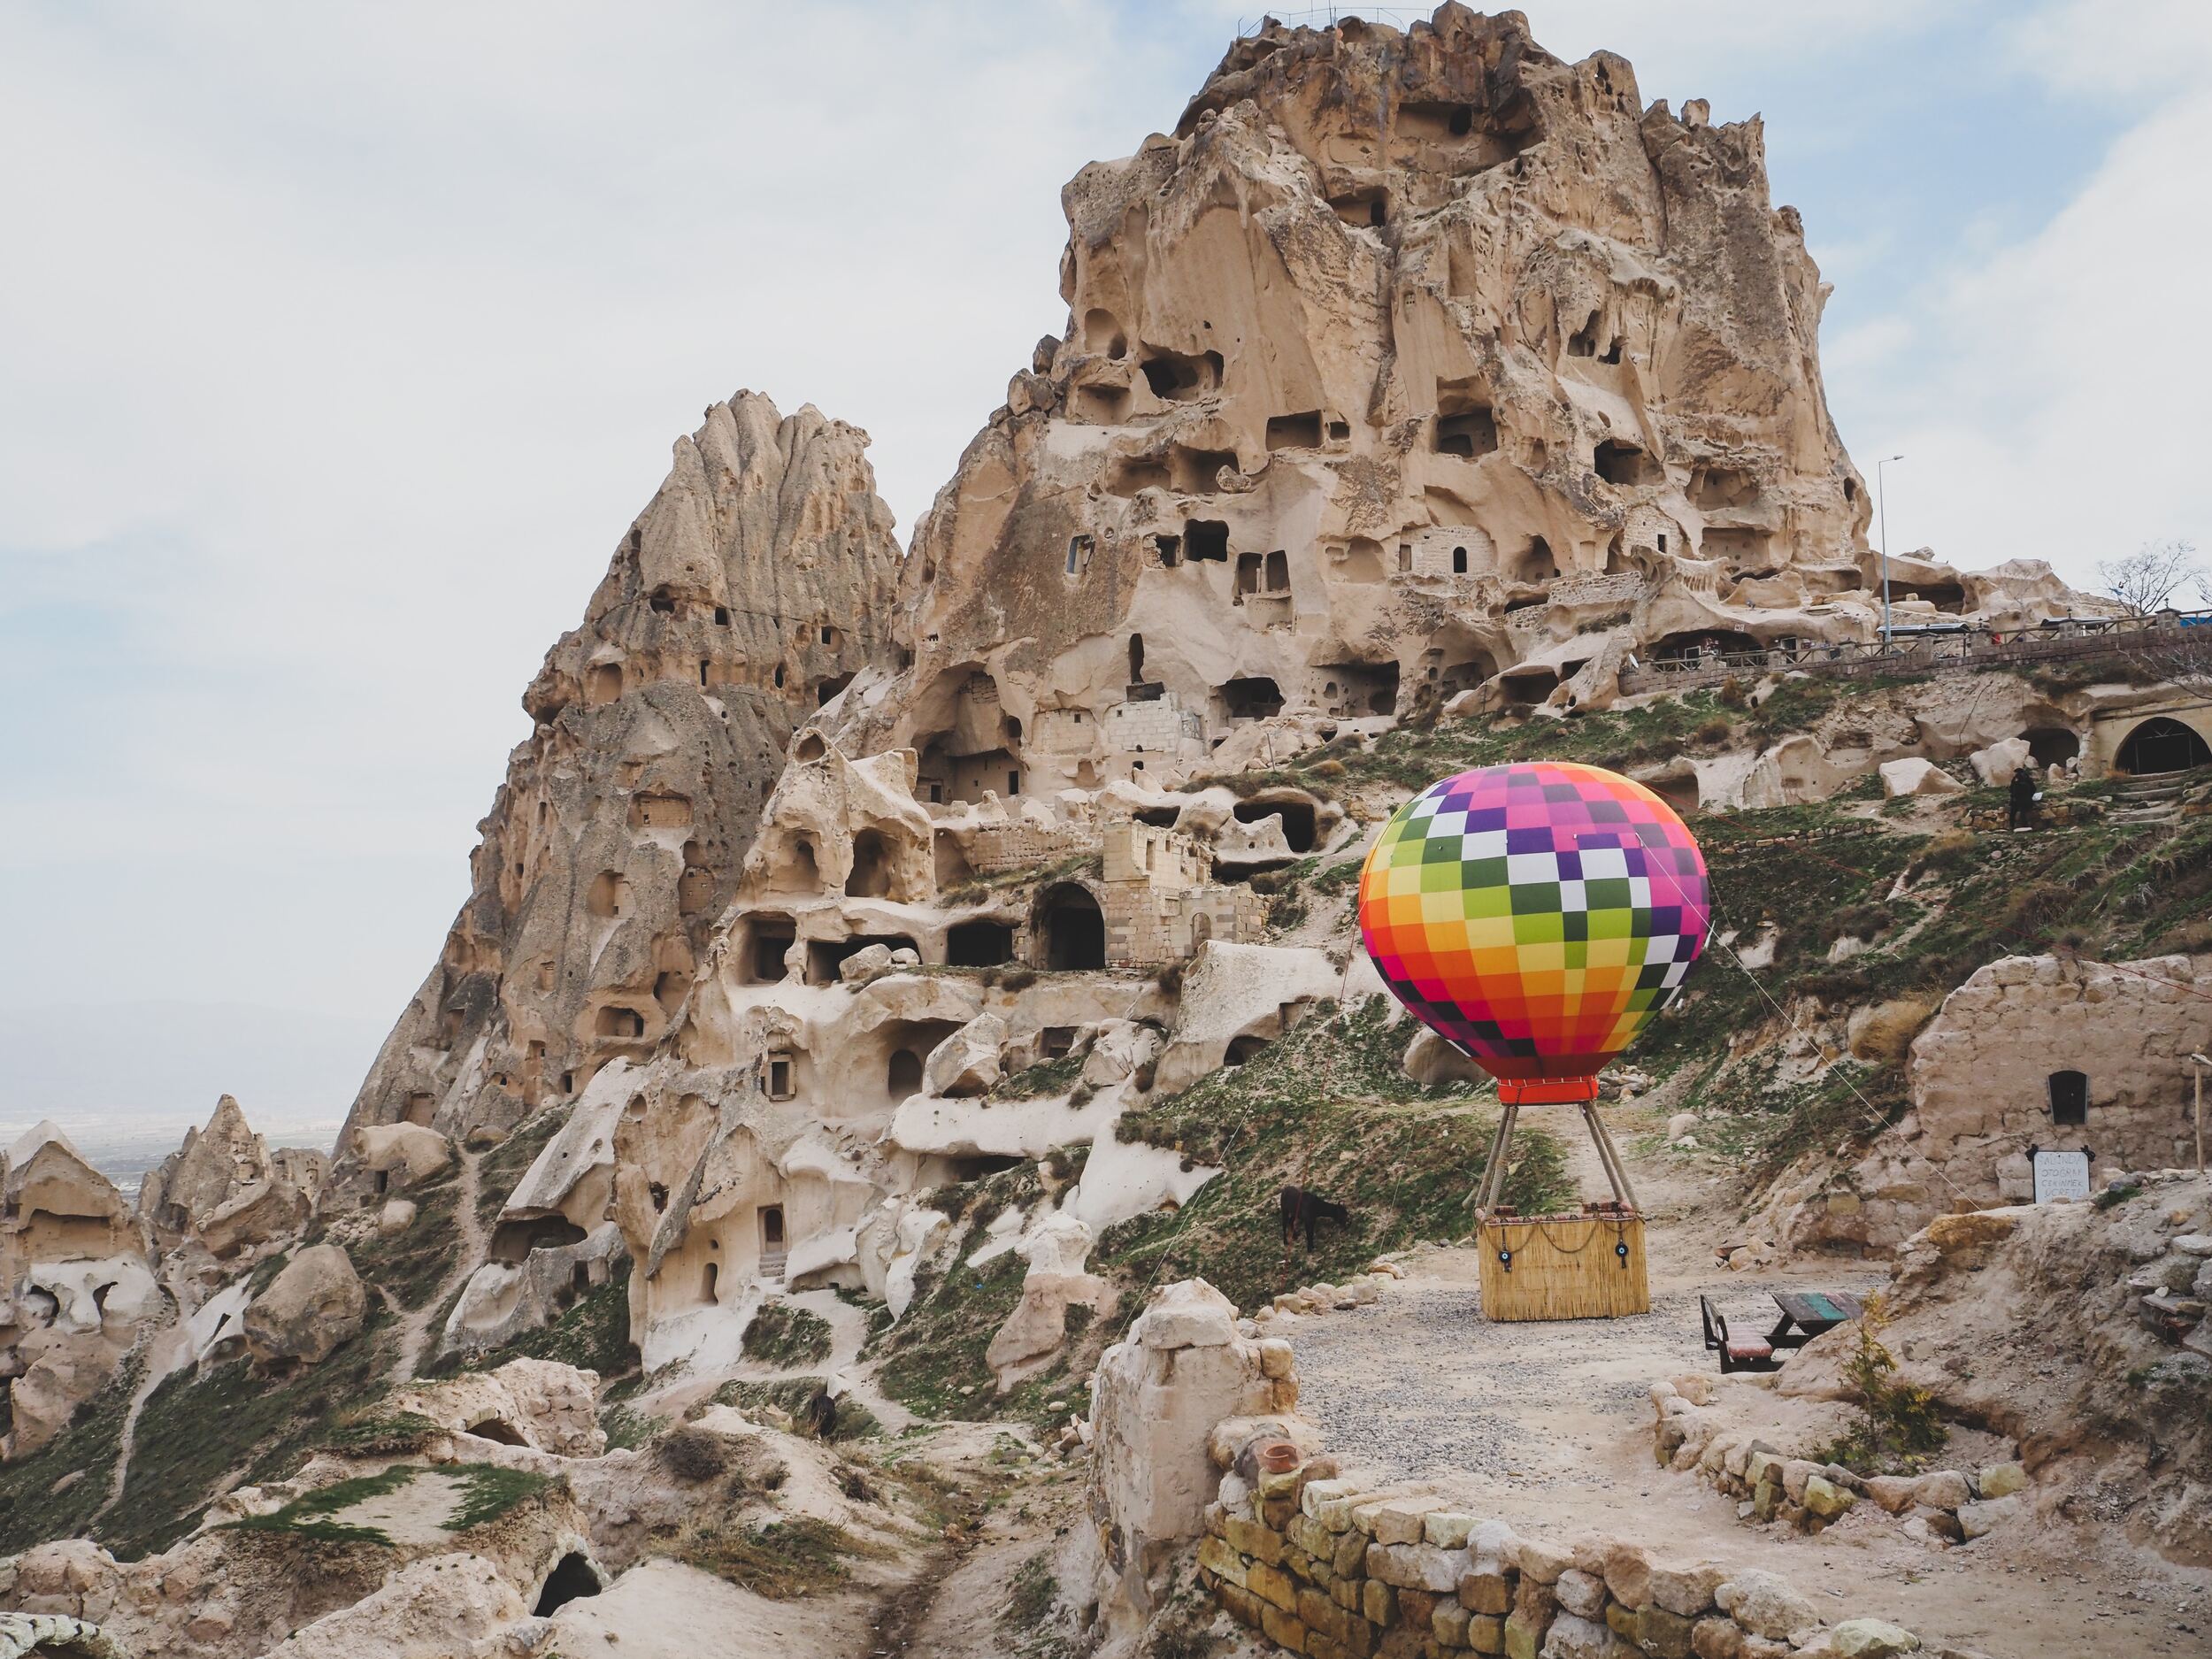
{"left": 1277, "top": 1119, "right": 2212, "bottom": 1659}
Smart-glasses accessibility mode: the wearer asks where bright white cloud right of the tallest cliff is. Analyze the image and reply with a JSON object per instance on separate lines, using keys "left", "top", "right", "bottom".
{"left": 1830, "top": 76, "right": 2212, "bottom": 587}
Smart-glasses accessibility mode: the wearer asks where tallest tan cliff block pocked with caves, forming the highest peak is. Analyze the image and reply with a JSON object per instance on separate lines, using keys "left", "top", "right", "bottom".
{"left": 863, "top": 4, "right": 1874, "bottom": 799}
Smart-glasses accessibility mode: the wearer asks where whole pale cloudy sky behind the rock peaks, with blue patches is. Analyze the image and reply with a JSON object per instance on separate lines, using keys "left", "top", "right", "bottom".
{"left": 0, "top": 0, "right": 2212, "bottom": 1122}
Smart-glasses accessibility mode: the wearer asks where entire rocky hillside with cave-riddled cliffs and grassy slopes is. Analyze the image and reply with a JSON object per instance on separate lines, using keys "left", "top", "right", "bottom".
{"left": 0, "top": 4, "right": 2212, "bottom": 1659}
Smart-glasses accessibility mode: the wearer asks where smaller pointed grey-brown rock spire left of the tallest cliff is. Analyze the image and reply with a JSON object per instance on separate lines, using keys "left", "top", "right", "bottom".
{"left": 341, "top": 392, "right": 898, "bottom": 1184}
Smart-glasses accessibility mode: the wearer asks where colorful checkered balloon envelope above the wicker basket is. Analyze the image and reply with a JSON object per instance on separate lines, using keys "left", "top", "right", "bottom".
{"left": 1361, "top": 761, "right": 1712, "bottom": 1079}
